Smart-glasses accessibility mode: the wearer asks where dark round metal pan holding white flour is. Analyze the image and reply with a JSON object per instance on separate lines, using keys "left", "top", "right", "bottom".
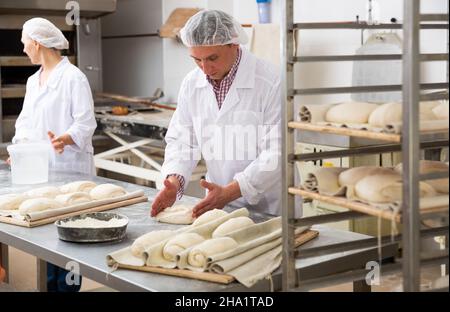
{"left": 55, "top": 212, "right": 128, "bottom": 243}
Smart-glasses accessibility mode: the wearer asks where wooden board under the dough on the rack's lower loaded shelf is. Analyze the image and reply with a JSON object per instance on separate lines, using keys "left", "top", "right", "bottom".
{"left": 289, "top": 187, "right": 448, "bottom": 223}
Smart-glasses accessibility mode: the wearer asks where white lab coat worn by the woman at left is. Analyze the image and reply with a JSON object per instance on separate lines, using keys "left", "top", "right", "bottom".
{"left": 12, "top": 57, "right": 97, "bottom": 175}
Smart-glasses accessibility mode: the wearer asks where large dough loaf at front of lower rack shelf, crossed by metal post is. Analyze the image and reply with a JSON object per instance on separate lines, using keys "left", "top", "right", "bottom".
{"left": 355, "top": 171, "right": 436, "bottom": 204}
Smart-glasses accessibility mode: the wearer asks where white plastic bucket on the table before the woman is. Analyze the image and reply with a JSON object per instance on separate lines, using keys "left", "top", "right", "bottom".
{"left": 7, "top": 143, "right": 50, "bottom": 184}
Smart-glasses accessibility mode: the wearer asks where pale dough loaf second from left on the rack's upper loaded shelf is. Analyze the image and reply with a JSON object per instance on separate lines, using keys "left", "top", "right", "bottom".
{"left": 325, "top": 102, "right": 378, "bottom": 124}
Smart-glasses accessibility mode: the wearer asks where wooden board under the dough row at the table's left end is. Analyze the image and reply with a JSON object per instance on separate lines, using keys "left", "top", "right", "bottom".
{"left": 0, "top": 196, "right": 148, "bottom": 228}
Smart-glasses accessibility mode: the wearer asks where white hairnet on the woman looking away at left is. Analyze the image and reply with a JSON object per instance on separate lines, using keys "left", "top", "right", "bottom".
{"left": 23, "top": 17, "right": 69, "bottom": 50}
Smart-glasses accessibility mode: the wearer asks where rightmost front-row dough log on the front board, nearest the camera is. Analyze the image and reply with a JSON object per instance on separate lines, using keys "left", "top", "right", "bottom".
{"left": 188, "top": 237, "right": 238, "bottom": 268}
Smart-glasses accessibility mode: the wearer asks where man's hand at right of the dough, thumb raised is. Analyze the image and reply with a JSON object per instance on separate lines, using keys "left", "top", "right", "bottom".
{"left": 192, "top": 179, "right": 242, "bottom": 218}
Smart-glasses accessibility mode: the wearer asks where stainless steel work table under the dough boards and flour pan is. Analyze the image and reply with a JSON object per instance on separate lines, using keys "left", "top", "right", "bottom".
{"left": 0, "top": 164, "right": 394, "bottom": 292}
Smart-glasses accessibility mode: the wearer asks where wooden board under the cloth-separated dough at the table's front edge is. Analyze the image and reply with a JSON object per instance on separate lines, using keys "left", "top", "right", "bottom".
{"left": 118, "top": 230, "right": 319, "bottom": 285}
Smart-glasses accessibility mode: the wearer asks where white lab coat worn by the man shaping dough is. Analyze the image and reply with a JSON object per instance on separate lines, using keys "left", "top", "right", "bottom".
{"left": 162, "top": 48, "right": 281, "bottom": 215}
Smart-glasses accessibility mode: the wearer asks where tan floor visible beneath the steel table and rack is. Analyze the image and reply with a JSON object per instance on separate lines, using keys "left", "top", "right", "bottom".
{"left": 0, "top": 248, "right": 448, "bottom": 292}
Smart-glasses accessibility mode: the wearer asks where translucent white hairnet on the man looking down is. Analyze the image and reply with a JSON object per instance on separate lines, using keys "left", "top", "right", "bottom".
{"left": 180, "top": 10, "right": 248, "bottom": 47}
